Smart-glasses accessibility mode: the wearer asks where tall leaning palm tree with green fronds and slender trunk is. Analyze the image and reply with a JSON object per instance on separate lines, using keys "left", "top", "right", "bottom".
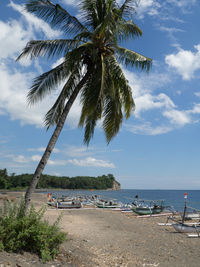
{"left": 17, "top": 0, "right": 151, "bottom": 214}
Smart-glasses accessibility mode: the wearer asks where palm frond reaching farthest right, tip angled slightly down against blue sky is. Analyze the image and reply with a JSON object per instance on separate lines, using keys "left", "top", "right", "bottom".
{"left": 115, "top": 46, "right": 152, "bottom": 71}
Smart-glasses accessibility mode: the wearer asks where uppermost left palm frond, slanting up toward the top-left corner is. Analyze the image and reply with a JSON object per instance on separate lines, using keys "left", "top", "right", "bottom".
{"left": 25, "top": 0, "right": 87, "bottom": 34}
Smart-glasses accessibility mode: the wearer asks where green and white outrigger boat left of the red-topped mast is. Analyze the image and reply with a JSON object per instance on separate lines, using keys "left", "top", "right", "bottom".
{"left": 131, "top": 199, "right": 164, "bottom": 215}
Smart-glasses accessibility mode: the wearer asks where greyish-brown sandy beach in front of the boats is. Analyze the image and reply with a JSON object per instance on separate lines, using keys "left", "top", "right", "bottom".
{"left": 0, "top": 192, "right": 200, "bottom": 267}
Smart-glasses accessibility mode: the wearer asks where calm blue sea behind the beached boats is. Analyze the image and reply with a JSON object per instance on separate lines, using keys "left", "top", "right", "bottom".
{"left": 45, "top": 189, "right": 200, "bottom": 211}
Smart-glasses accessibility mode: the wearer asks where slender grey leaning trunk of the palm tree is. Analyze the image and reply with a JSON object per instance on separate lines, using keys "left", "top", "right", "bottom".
{"left": 25, "top": 71, "right": 90, "bottom": 214}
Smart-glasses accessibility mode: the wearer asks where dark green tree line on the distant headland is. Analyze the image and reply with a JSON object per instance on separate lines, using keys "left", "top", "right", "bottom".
{"left": 0, "top": 169, "right": 115, "bottom": 190}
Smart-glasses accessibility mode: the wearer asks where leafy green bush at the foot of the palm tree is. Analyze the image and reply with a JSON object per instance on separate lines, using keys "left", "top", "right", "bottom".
{"left": 0, "top": 199, "right": 66, "bottom": 262}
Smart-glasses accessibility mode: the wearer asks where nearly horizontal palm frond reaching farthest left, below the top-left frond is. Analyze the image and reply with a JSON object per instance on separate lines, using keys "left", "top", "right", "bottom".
{"left": 17, "top": 39, "right": 80, "bottom": 61}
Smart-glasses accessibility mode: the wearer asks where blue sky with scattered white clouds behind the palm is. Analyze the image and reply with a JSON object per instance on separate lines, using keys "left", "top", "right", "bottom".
{"left": 0, "top": 0, "right": 200, "bottom": 190}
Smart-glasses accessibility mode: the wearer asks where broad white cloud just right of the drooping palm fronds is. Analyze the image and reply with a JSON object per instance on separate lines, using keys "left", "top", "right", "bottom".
{"left": 122, "top": 66, "right": 194, "bottom": 135}
